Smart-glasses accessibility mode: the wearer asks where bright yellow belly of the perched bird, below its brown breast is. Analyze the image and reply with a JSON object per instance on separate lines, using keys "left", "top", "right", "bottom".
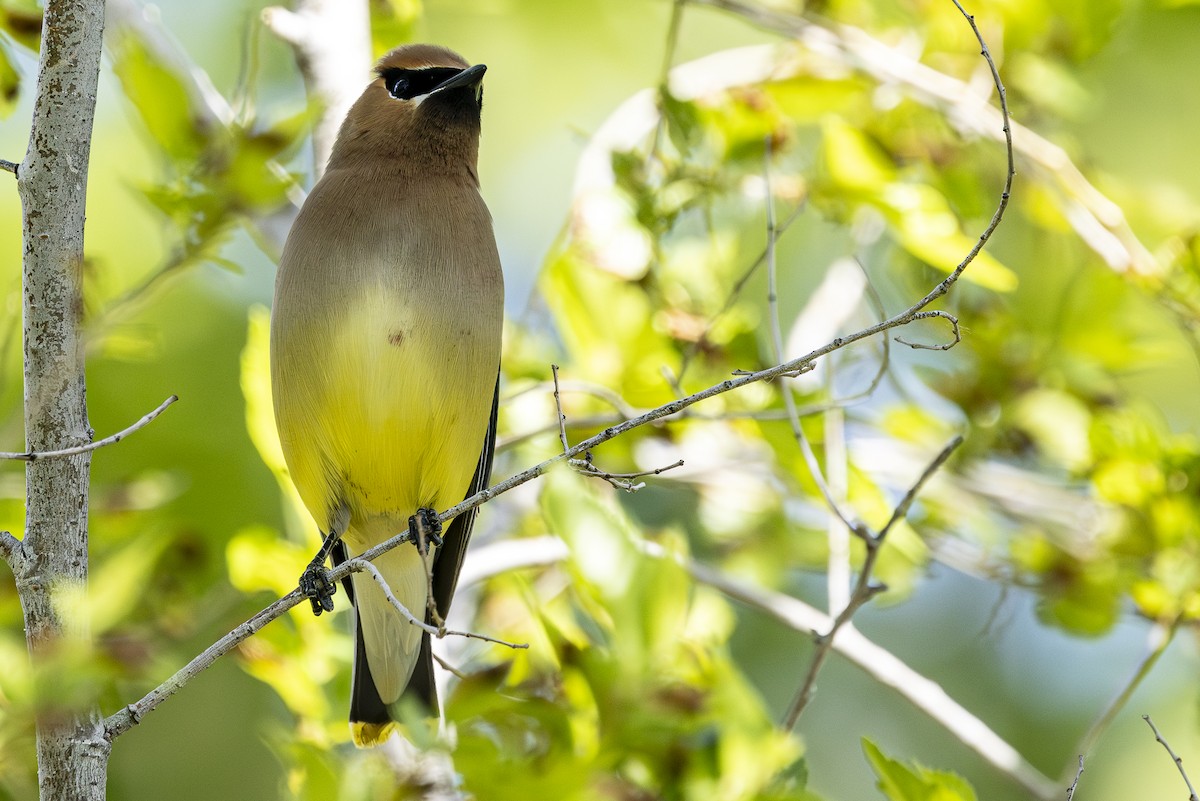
{"left": 275, "top": 284, "right": 499, "bottom": 541}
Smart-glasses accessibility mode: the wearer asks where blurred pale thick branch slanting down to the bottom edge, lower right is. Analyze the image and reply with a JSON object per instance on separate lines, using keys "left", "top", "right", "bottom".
{"left": 635, "top": 541, "right": 1061, "bottom": 801}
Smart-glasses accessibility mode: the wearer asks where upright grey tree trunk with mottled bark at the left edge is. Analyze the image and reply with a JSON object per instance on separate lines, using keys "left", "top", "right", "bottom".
{"left": 11, "top": 0, "right": 109, "bottom": 801}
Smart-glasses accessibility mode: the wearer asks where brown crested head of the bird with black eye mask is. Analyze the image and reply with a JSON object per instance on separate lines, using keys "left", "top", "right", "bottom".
{"left": 329, "top": 44, "right": 487, "bottom": 177}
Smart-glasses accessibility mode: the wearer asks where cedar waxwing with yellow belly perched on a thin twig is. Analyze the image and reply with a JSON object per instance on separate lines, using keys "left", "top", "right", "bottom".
{"left": 271, "top": 44, "right": 504, "bottom": 746}
